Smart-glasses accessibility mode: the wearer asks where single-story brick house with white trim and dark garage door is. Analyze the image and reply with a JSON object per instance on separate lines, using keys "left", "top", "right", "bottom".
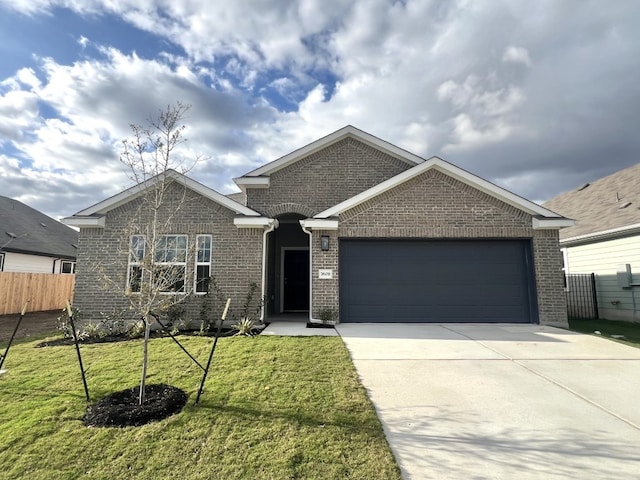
{"left": 64, "top": 126, "right": 573, "bottom": 326}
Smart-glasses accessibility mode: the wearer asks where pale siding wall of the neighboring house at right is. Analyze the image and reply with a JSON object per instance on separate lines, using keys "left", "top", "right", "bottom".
{"left": 567, "top": 237, "right": 640, "bottom": 320}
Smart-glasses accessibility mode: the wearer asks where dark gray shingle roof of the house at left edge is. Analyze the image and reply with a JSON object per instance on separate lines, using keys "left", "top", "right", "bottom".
{"left": 0, "top": 195, "right": 78, "bottom": 259}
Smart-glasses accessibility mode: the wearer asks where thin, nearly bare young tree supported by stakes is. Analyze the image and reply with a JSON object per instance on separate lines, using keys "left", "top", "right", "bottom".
{"left": 120, "top": 102, "right": 199, "bottom": 404}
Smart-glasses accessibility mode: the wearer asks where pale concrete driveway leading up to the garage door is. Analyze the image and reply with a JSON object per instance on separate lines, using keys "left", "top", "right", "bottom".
{"left": 337, "top": 324, "right": 640, "bottom": 480}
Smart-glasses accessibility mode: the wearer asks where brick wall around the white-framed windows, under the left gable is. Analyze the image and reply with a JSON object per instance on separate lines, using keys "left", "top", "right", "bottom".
{"left": 75, "top": 183, "right": 263, "bottom": 324}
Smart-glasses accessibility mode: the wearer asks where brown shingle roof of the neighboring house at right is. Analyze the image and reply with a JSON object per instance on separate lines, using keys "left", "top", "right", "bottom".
{"left": 544, "top": 163, "right": 640, "bottom": 244}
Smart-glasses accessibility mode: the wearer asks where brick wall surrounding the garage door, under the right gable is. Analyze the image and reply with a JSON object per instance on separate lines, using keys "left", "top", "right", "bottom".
{"left": 312, "top": 170, "right": 567, "bottom": 326}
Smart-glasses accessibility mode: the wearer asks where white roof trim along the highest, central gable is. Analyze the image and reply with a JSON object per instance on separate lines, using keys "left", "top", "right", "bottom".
{"left": 234, "top": 125, "right": 424, "bottom": 185}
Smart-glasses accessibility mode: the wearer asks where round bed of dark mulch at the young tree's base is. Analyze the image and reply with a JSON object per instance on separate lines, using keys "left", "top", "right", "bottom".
{"left": 82, "top": 383, "right": 187, "bottom": 427}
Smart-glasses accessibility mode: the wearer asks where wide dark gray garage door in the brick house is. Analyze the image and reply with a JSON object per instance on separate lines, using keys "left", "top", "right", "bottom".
{"left": 340, "top": 240, "right": 537, "bottom": 323}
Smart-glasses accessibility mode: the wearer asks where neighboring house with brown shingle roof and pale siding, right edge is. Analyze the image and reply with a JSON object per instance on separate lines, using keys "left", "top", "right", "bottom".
{"left": 544, "top": 164, "right": 640, "bottom": 321}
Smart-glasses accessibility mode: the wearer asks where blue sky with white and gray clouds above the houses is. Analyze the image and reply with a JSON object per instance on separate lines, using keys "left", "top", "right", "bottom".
{"left": 0, "top": 0, "right": 640, "bottom": 218}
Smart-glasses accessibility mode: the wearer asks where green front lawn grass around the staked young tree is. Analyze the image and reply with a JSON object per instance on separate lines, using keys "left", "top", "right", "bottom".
{"left": 0, "top": 336, "right": 400, "bottom": 480}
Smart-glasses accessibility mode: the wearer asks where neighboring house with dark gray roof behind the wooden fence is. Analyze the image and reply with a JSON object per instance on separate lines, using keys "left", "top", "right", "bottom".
{"left": 0, "top": 195, "right": 78, "bottom": 273}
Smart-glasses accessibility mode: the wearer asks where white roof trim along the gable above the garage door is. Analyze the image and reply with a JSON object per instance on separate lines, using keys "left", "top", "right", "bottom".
{"left": 314, "top": 157, "right": 573, "bottom": 228}
